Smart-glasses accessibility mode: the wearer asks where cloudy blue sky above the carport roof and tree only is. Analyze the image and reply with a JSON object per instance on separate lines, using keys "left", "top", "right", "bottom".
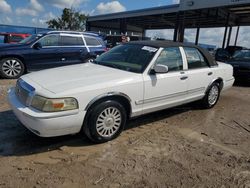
{"left": 0, "top": 0, "right": 178, "bottom": 27}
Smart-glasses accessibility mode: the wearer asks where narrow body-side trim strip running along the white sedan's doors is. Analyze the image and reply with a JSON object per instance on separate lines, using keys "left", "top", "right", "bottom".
{"left": 135, "top": 87, "right": 205, "bottom": 105}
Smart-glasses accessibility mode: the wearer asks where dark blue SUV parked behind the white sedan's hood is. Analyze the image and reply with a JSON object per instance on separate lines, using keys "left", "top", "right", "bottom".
{"left": 0, "top": 31, "right": 106, "bottom": 78}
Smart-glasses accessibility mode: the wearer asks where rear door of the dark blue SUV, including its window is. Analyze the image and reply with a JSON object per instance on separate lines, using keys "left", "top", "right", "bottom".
{"left": 60, "top": 34, "right": 88, "bottom": 65}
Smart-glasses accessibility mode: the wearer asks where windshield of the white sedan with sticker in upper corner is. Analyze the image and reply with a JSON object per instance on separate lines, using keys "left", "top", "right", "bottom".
{"left": 94, "top": 44, "right": 158, "bottom": 73}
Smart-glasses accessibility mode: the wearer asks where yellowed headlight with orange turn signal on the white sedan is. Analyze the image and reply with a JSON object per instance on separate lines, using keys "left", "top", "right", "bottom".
{"left": 31, "top": 95, "right": 78, "bottom": 112}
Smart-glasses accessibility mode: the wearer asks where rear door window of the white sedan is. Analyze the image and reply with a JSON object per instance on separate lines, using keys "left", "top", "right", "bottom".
{"left": 184, "top": 47, "right": 208, "bottom": 69}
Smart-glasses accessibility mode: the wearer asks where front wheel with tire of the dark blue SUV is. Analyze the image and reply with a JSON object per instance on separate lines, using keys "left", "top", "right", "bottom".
{"left": 0, "top": 57, "right": 25, "bottom": 79}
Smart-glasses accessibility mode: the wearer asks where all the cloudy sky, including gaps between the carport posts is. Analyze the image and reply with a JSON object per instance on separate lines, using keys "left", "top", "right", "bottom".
{"left": 0, "top": 0, "right": 250, "bottom": 48}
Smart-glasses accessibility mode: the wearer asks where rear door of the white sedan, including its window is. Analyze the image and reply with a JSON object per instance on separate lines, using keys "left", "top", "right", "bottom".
{"left": 184, "top": 47, "right": 214, "bottom": 99}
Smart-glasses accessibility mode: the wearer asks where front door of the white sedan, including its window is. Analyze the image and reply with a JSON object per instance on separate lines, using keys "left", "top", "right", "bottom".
{"left": 140, "top": 47, "right": 188, "bottom": 113}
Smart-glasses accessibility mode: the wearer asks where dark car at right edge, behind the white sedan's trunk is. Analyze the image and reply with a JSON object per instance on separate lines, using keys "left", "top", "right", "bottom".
{"left": 226, "top": 49, "right": 250, "bottom": 81}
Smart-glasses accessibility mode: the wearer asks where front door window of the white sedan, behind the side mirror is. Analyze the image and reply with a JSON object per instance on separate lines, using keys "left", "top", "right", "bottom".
{"left": 156, "top": 47, "right": 183, "bottom": 72}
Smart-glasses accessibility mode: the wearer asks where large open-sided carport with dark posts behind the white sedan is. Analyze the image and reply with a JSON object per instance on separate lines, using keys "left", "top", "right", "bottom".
{"left": 87, "top": 0, "right": 250, "bottom": 48}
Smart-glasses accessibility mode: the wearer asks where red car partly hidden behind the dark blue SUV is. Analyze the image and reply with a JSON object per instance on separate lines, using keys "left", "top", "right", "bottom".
{"left": 0, "top": 33, "right": 30, "bottom": 43}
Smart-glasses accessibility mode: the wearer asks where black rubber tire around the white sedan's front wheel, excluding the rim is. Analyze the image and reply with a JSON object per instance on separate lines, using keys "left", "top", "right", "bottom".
{"left": 85, "top": 100, "right": 127, "bottom": 143}
